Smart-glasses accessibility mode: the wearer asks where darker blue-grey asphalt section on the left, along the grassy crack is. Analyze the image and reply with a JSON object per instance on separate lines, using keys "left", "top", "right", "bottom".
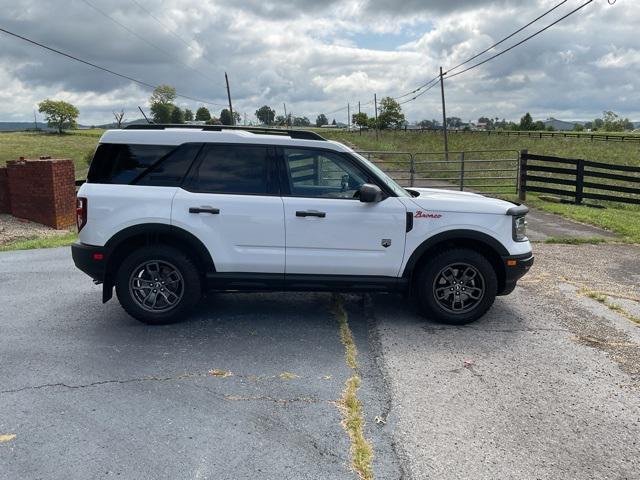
{"left": 0, "top": 249, "right": 400, "bottom": 480}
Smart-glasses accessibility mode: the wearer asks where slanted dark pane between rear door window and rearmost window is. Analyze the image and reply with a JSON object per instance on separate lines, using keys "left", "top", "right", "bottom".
{"left": 133, "top": 143, "right": 202, "bottom": 187}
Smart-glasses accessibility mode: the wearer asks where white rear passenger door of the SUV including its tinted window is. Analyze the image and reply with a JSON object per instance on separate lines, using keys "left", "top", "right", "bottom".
{"left": 171, "top": 144, "right": 285, "bottom": 273}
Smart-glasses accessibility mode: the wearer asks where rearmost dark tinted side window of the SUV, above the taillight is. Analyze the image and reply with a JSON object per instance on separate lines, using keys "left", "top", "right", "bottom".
{"left": 87, "top": 143, "right": 176, "bottom": 184}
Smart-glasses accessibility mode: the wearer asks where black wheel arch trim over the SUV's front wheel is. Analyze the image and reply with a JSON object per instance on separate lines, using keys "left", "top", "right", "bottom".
{"left": 402, "top": 229, "right": 509, "bottom": 292}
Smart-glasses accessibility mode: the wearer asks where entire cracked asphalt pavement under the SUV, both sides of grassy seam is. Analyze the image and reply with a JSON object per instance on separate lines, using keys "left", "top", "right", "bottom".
{"left": 0, "top": 245, "right": 640, "bottom": 480}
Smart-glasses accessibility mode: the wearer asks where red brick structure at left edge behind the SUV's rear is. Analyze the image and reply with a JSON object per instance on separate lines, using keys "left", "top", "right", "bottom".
{"left": 0, "top": 158, "right": 76, "bottom": 230}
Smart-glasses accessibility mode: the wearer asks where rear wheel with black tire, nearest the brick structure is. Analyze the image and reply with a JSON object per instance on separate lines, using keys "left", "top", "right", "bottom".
{"left": 115, "top": 245, "right": 201, "bottom": 325}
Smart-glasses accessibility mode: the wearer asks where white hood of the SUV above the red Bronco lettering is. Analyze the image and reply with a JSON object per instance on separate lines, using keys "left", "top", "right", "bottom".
{"left": 407, "top": 188, "right": 514, "bottom": 215}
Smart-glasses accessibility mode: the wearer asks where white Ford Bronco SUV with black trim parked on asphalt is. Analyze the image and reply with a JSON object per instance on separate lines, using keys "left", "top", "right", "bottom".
{"left": 72, "top": 125, "right": 533, "bottom": 324}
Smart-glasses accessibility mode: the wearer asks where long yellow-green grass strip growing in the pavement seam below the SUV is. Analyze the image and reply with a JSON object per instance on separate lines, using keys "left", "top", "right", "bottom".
{"left": 333, "top": 295, "right": 373, "bottom": 480}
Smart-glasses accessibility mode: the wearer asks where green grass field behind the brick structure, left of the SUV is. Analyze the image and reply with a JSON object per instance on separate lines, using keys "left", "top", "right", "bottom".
{"left": 0, "top": 129, "right": 104, "bottom": 178}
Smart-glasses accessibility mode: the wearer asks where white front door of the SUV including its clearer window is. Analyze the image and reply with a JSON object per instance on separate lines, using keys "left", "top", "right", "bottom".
{"left": 281, "top": 148, "right": 407, "bottom": 277}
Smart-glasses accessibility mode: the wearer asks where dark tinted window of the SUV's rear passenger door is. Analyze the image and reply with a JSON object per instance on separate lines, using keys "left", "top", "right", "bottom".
{"left": 186, "top": 144, "right": 272, "bottom": 195}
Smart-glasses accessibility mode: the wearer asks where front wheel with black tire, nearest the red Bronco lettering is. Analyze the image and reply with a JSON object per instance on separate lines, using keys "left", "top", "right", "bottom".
{"left": 414, "top": 248, "right": 498, "bottom": 325}
